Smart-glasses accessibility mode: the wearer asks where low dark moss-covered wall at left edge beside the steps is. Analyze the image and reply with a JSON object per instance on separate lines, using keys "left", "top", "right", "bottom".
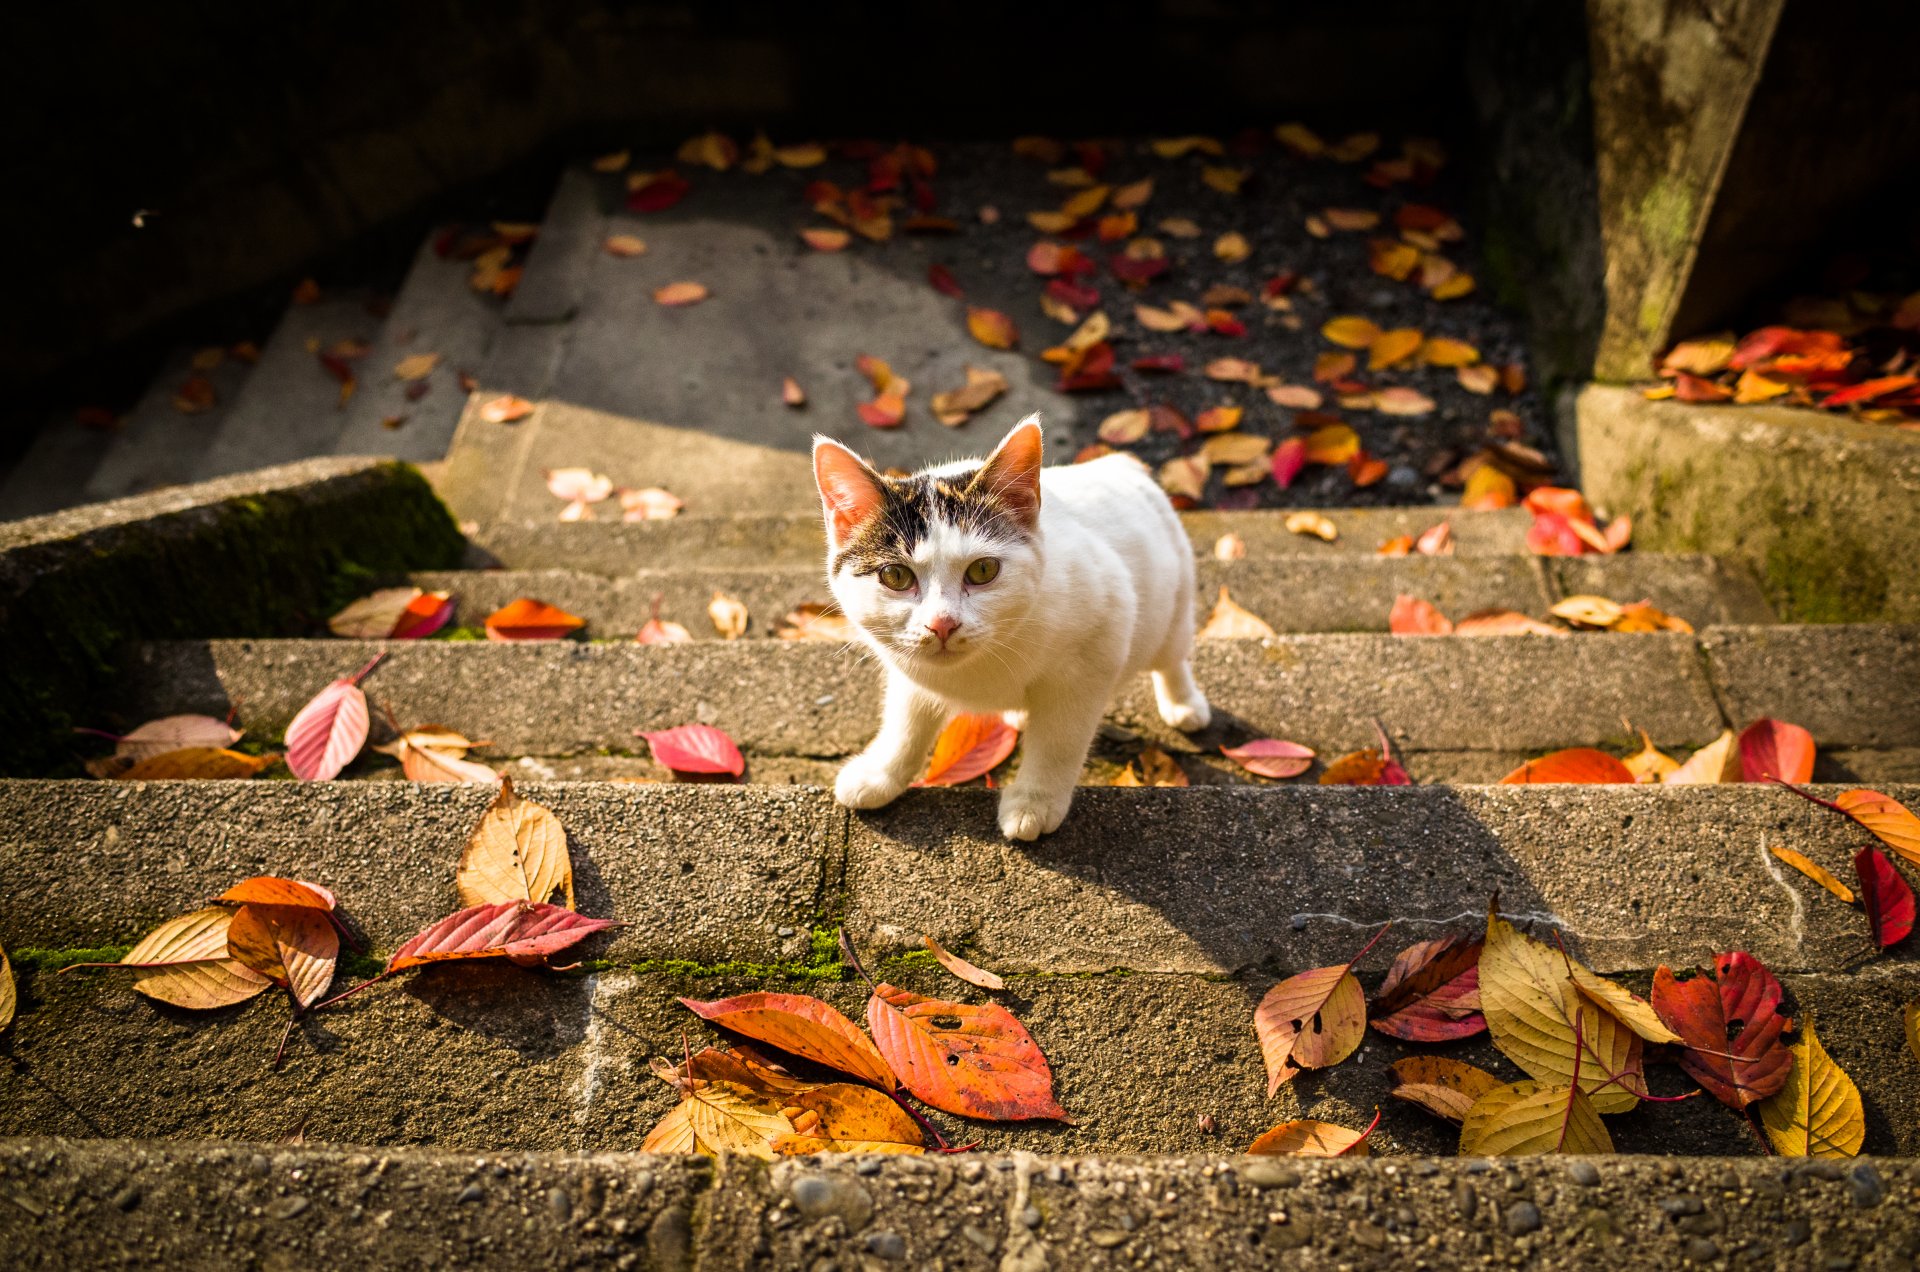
{"left": 0, "top": 463, "right": 465, "bottom": 774}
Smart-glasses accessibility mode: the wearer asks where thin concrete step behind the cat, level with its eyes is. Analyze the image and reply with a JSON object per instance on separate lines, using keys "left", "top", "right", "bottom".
{"left": 413, "top": 544, "right": 1772, "bottom": 640}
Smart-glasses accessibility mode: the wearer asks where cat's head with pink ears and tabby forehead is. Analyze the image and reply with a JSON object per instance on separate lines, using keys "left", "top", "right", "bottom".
{"left": 814, "top": 415, "right": 1041, "bottom": 671}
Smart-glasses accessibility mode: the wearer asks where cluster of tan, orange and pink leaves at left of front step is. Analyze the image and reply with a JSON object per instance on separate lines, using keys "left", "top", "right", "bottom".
{"left": 58, "top": 778, "right": 618, "bottom": 1063}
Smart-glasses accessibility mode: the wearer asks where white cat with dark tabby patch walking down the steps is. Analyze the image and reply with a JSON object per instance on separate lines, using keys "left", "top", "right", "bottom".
{"left": 814, "top": 415, "right": 1212, "bottom": 840}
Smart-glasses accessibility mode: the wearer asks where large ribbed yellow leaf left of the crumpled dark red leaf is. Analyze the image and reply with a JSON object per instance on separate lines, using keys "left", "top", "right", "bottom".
{"left": 1480, "top": 913, "right": 1642, "bottom": 1113}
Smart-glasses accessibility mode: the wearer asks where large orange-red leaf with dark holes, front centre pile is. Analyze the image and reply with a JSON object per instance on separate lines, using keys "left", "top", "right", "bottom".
{"left": 866, "top": 984, "right": 1069, "bottom": 1122}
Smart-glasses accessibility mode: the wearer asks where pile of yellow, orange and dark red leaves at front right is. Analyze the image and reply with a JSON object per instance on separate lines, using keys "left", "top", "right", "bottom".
{"left": 1248, "top": 907, "right": 1889, "bottom": 1157}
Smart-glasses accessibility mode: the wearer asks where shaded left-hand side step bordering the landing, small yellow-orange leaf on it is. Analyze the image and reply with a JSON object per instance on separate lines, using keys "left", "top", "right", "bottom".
{"left": 334, "top": 232, "right": 501, "bottom": 463}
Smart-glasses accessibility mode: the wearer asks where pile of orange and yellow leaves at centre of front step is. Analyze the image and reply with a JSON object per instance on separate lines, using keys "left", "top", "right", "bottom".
{"left": 641, "top": 932, "right": 1069, "bottom": 1159}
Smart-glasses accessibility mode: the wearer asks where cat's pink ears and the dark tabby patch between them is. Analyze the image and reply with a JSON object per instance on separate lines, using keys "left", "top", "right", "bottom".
{"left": 814, "top": 415, "right": 1041, "bottom": 575}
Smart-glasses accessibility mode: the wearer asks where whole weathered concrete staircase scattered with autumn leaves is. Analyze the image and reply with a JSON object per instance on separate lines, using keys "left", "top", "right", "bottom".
{"left": 0, "top": 151, "right": 1920, "bottom": 1268}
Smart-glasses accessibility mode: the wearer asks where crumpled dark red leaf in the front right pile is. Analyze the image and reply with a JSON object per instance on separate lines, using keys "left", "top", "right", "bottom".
{"left": 1647, "top": 951, "right": 1793, "bottom": 1109}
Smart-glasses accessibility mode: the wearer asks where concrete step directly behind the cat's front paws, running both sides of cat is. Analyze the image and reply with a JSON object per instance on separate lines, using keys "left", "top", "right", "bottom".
{"left": 119, "top": 626, "right": 1920, "bottom": 782}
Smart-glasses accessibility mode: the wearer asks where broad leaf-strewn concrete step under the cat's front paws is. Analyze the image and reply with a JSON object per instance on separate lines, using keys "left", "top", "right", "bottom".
{"left": 0, "top": 782, "right": 1920, "bottom": 1153}
